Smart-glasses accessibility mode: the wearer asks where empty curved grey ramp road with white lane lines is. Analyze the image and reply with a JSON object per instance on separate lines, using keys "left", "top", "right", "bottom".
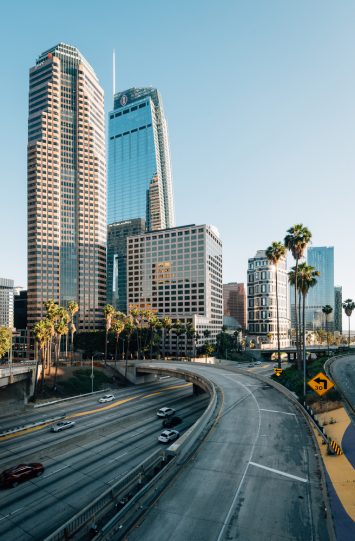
{"left": 127, "top": 365, "right": 329, "bottom": 541}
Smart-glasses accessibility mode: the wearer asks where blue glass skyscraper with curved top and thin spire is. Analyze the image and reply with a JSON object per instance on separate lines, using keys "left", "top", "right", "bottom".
{"left": 108, "top": 88, "right": 175, "bottom": 231}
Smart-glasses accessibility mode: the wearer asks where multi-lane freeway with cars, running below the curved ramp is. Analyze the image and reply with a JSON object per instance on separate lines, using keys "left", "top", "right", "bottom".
{"left": 0, "top": 378, "right": 208, "bottom": 541}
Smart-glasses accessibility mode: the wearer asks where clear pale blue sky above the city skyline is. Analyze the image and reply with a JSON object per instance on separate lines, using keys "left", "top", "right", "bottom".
{"left": 0, "top": 0, "right": 355, "bottom": 310}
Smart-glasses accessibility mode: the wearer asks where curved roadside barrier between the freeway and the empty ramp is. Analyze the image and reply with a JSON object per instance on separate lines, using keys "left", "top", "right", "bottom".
{"left": 44, "top": 367, "right": 221, "bottom": 541}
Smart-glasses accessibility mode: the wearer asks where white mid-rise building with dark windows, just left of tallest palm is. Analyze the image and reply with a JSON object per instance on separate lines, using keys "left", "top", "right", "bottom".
{"left": 248, "top": 250, "right": 291, "bottom": 347}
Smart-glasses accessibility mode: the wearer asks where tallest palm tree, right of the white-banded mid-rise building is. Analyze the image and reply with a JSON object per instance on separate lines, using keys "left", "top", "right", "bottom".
{"left": 284, "top": 224, "right": 312, "bottom": 369}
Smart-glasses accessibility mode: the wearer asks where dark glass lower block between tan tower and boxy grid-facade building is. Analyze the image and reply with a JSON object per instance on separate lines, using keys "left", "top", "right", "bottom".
{"left": 107, "top": 218, "right": 145, "bottom": 313}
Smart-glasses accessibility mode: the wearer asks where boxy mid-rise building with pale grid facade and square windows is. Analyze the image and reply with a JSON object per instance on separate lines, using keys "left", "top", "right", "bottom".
{"left": 127, "top": 225, "right": 223, "bottom": 353}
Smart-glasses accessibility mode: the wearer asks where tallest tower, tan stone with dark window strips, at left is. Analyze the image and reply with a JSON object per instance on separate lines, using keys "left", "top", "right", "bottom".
{"left": 28, "top": 43, "right": 106, "bottom": 330}
